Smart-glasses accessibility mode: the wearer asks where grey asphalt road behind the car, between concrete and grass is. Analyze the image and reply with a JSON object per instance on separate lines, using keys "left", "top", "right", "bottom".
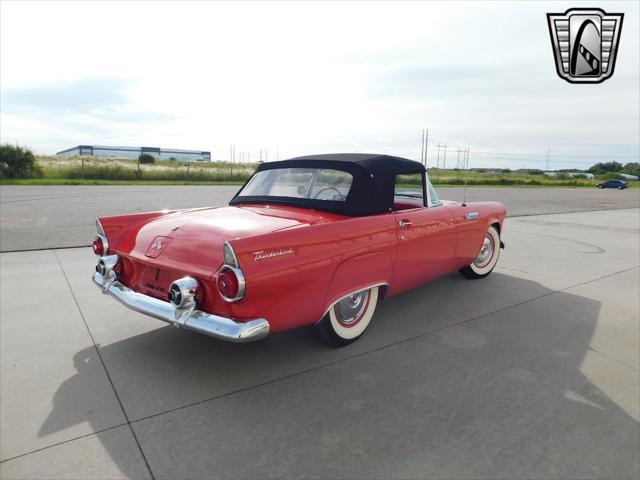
{"left": 0, "top": 185, "right": 640, "bottom": 252}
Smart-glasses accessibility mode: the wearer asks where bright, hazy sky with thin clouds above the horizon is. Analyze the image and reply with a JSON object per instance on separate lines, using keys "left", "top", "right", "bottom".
{"left": 0, "top": 1, "right": 640, "bottom": 169}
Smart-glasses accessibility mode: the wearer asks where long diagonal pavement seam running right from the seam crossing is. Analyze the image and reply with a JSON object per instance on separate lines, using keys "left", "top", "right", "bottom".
{"left": 131, "top": 265, "right": 638, "bottom": 423}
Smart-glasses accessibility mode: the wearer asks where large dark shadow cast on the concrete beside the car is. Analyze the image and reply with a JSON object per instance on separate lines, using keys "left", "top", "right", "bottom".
{"left": 39, "top": 272, "right": 640, "bottom": 478}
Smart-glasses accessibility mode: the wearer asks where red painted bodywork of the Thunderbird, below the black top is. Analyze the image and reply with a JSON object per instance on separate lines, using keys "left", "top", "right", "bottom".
{"left": 99, "top": 201, "right": 506, "bottom": 332}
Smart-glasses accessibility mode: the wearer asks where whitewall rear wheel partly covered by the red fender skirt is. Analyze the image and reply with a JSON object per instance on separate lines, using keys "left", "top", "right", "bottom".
{"left": 316, "top": 287, "right": 378, "bottom": 347}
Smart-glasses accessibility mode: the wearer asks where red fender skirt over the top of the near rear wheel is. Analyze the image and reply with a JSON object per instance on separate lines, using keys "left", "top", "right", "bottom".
{"left": 320, "top": 252, "right": 393, "bottom": 320}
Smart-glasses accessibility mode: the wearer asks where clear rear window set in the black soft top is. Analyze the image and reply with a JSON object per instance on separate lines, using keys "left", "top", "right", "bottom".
{"left": 238, "top": 168, "right": 353, "bottom": 202}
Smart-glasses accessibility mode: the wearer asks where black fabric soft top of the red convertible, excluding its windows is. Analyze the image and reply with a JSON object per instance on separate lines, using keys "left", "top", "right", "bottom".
{"left": 229, "top": 153, "right": 425, "bottom": 215}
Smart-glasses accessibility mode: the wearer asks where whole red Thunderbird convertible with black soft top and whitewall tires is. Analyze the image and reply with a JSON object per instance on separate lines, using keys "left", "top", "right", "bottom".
{"left": 93, "top": 154, "right": 506, "bottom": 346}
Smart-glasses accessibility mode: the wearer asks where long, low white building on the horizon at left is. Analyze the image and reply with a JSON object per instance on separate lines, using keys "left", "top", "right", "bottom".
{"left": 56, "top": 145, "right": 211, "bottom": 162}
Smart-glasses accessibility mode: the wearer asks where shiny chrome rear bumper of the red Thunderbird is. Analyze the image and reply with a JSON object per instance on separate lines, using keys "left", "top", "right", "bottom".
{"left": 93, "top": 273, "right": 269, "bottom": 342}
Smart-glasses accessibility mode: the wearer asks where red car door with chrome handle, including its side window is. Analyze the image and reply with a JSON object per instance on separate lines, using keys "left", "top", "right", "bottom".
{"left": 393, "top": 173, "right": 456, "bottom": 290}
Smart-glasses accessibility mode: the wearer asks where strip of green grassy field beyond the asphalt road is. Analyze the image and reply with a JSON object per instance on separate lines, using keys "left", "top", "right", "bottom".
{"left": 0, "top": 156, "right": 639, "bottom": 188}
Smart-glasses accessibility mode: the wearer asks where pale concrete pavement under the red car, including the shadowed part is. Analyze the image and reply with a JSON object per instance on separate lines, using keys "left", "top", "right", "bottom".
{"left": 0, "top": 208, "right": 640, "bottom": 479}
